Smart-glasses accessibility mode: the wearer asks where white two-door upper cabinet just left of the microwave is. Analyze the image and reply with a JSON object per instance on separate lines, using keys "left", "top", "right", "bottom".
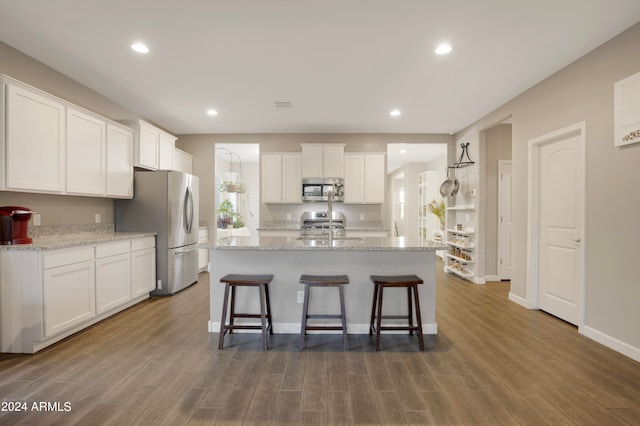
{"left": 261, "top": 152, "right": 302, "bottom": 204}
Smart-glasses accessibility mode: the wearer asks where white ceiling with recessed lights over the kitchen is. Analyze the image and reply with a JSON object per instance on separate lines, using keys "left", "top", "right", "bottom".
{"left": 0, "top": 0, "right": 640, "bottom": 134}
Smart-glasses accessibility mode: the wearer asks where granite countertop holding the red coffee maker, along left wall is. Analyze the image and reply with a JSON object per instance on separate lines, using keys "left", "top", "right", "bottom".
{"left": 0, "top": 232, "right": 156, "bottom": 250}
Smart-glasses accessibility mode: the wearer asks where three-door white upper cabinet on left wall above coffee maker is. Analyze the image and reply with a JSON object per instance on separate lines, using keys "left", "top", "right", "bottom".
{"left": 0, "top": 76, "right": 133, "bottom": 198}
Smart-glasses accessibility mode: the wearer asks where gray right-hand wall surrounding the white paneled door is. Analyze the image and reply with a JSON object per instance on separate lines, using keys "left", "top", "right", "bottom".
{"left": 456, "top": 23, "right": 640, "bottom": 357}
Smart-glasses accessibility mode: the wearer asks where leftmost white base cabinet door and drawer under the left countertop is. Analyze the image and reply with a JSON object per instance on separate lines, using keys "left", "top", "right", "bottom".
{"left": 43, "top": 246, "right": 96, "bottom": 337}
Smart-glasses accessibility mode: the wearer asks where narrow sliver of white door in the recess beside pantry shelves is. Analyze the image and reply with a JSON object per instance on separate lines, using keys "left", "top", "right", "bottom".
{"left": 498, "top": 161, "right": 513, "bottom": 280}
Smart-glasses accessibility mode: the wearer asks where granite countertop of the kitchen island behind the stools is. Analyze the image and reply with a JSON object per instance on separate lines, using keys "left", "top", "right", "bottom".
{"left": 198, "top": 236, "right": 447, "bottom": 251}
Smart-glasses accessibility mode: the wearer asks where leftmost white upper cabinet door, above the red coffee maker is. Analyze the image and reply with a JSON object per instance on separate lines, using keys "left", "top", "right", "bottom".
{"left": 4, "top": 84, "right": 65, "bottom": 193}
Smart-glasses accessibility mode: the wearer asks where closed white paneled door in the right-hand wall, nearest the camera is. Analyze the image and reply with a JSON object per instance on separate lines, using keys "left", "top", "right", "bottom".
{"left": 534, "top": 124, "right": 585, "bottom": 325}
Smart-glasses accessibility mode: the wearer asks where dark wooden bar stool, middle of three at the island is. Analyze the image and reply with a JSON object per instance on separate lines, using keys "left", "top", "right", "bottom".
{"left": 300, "top": 274, "right": 349, "bottom": 351}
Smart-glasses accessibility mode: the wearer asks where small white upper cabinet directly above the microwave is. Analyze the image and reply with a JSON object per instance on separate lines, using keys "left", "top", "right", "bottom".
{"left": 301, "top": 144, "right": 344, "bottom": 178}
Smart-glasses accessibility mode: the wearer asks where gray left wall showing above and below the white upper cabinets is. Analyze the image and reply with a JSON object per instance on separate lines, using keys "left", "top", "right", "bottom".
{"left": 0, "top": 42, "right": 137, "bottom": 226}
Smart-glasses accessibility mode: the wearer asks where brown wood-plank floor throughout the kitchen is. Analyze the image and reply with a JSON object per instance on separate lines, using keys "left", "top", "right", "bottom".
{"left": 0, "top": 264, "right": 640, "bottom": 425}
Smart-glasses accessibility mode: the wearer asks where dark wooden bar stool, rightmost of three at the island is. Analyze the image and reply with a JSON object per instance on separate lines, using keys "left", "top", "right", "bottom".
{"left": 369, "top": 275, "right": 424, "bottom": 351}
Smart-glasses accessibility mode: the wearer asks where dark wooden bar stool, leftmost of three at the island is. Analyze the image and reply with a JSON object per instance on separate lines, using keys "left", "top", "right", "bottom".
{"left": 218, "top": 274, "right": 273, "bottom": 351}
